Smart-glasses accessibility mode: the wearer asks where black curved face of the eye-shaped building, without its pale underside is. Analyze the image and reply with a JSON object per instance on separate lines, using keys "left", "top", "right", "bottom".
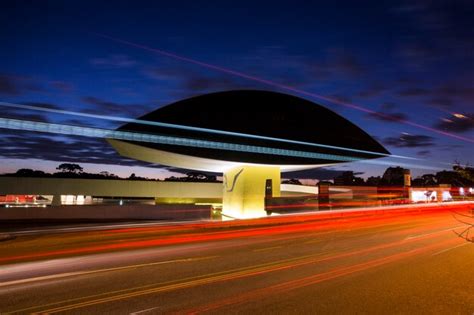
{"left": 119, "top": 90, "right": 389, "bottom": 164}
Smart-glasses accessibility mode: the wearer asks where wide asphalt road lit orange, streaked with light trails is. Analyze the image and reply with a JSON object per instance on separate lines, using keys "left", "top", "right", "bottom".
{"left": 0, "top": 204, "right": 474, "bottom": 315}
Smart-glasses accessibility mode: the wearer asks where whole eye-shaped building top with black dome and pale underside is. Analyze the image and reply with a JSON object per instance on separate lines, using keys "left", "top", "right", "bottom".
{"left": 109, "top": 90, "right": 389, "bottom": 172}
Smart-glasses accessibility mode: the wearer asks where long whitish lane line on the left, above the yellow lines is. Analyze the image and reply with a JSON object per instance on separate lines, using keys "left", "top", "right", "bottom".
{"left": 0, "top": 256, "right": 219, "bottom": 287}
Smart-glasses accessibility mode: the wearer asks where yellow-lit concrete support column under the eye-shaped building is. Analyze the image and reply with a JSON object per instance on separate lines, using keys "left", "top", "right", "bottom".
{"left": 222, "top": 165, "right": 281, "bottom": 219}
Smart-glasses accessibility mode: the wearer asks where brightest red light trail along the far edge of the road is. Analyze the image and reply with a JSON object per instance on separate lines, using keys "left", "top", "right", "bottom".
{"left": 0, "top": 205, "right": 468, "bottom": 263}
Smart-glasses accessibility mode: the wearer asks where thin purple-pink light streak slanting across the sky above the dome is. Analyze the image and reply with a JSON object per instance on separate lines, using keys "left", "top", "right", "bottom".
{"left": 94, "top": 33, "right": 474, "bottom": 143}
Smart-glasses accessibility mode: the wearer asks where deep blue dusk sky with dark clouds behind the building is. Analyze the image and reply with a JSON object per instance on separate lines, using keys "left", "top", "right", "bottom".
{"left": 0, "top": 0, "right": 474, "bottom": 178}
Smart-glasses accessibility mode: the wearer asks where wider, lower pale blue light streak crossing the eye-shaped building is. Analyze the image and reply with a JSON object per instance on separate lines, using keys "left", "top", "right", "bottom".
{"left": 0, "top": 118, "right": 441, "bottom": 170}
